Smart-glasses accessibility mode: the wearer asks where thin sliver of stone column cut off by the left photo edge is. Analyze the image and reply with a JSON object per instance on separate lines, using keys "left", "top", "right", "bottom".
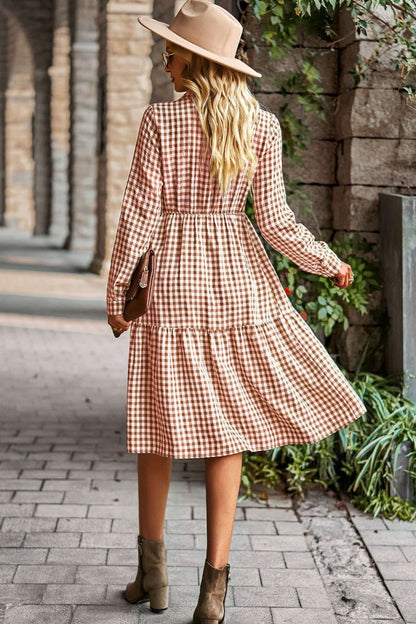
{"left": 0, "top": 10, "right": 7, "bottom": 227}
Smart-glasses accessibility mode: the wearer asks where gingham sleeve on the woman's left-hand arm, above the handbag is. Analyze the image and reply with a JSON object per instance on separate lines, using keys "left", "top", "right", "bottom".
{"left": 107, "top": 105, "right": 163, "bottom": 314}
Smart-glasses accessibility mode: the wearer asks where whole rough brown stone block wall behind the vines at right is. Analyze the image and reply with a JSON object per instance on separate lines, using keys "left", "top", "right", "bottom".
{"left": 248, "top": 12, "right": 416, "bottom": 371}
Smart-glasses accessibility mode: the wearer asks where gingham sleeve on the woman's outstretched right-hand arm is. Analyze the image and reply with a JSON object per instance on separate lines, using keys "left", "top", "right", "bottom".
{"left": 253, "top": 114, "right": 341, "bottom": 276}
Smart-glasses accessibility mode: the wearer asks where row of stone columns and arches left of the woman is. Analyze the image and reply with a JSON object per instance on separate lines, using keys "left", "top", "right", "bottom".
{"left": 0, "top": 0, "right": 174, "bottom": 260}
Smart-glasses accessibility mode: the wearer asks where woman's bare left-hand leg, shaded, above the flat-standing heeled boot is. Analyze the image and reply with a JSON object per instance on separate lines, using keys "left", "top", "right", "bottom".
{"left": 137, "top": 453, "right": 172, "bottom": 541}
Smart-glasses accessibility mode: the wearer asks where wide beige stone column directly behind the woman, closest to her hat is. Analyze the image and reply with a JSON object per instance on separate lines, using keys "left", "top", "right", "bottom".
{"left": 91, "top": 0, "right": 153, "bottom": 272}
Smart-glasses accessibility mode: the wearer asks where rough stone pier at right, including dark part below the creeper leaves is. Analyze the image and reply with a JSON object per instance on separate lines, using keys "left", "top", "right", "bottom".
{"left": 332, "top": 13, "right": 416, "bottom": 370}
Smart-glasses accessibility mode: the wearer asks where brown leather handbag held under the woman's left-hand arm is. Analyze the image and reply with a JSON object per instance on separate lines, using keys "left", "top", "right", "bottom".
{"left": 113, "top": 247, "right": 156, "bottom": 338}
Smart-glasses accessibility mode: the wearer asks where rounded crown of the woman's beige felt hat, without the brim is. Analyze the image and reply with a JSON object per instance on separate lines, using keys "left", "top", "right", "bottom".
{"left": 169, "top": 0, "right": 243, "bottom": 58}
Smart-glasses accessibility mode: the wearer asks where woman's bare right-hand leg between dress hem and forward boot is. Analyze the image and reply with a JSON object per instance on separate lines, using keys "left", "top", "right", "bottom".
{"left": 205, "top": 453, "right": 243, "bottom": 568}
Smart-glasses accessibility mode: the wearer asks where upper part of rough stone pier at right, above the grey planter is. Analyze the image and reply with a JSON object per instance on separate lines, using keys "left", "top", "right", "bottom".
{"left": 333, "top": 13, "right": 416, "bottom": 232}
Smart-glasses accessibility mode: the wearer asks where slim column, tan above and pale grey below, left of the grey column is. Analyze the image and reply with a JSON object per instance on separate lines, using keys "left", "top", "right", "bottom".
{"left": 49, "top": 0, "right": 71, "bottom": 241}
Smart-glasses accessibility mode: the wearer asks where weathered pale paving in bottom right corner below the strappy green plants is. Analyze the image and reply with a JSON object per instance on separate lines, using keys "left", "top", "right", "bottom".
{"left": 296, "top": 489, "right": 416, "bottom": 624}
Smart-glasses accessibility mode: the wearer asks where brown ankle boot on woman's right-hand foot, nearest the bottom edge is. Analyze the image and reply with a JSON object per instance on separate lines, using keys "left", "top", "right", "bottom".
{"left": 193, "top": 559, "right": 230, "bottom": 624}
